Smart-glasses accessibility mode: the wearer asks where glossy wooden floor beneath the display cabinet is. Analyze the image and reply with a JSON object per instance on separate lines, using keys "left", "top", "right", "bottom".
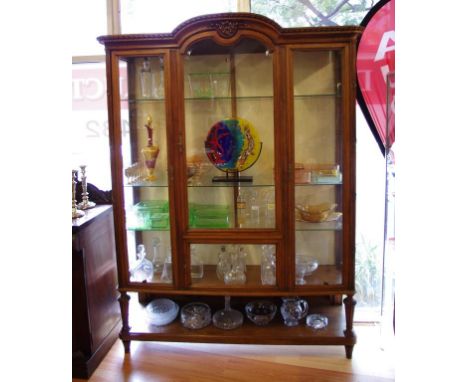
{"left": 73, "top": 325, "right": 395, "bottom": 382}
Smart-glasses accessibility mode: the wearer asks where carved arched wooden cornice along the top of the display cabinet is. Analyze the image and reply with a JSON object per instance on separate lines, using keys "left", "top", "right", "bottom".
{"left": 98, "top": 12, "right": 362, "bottom": 53}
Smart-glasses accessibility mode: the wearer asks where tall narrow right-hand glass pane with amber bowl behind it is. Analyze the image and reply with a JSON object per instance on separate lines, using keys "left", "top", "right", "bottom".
{"left": 293, "top": 50, "right": 343, "bottom": 285}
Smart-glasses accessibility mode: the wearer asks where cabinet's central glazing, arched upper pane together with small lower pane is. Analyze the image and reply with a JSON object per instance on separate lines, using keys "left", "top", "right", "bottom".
{"left": 183, "top": 38, "right": 277, "bottom": 289}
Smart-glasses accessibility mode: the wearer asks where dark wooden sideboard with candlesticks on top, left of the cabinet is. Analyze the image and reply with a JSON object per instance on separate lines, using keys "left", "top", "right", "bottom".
{"left": 72, "top": 205, "right": 121, "bottom": 378}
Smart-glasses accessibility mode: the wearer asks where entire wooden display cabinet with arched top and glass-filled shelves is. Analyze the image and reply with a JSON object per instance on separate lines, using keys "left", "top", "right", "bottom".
{"left": 98, "top": 13, "right": 361, "bottom": 358}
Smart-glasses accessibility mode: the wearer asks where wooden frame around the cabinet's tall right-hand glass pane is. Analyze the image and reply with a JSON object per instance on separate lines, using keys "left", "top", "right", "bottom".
{"left": 285, "top": 39, "right": 356, "bottom": 294}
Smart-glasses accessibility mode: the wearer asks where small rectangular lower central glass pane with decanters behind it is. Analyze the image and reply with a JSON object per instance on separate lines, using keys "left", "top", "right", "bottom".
{"left": 190, "top": 244, "right": 276, "bottom": 288}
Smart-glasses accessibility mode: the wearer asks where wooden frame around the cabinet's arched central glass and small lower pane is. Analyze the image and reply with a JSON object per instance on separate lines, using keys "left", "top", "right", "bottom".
{"left": 174, "top": 29, "right": 288, "bottom": 294}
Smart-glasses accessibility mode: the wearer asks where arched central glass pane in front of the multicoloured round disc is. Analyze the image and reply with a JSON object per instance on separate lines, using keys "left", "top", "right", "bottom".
{"left": 184, "top": 39, "right": 275, "bottom": 229}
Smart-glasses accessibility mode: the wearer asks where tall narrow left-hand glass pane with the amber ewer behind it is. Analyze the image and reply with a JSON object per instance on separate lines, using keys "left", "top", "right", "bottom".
{"left": 119, "top": 56, "right": 172, "bottom": 283}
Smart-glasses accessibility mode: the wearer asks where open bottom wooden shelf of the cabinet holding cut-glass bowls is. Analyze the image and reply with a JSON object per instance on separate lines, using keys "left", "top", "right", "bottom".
{"left": 121, "top": 292, "right": 356, "bottom": 345}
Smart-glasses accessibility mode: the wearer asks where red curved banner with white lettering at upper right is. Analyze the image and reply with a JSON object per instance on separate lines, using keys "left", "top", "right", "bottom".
{"left": 356, "top": 0, "right": 395, "bottom": 149}
